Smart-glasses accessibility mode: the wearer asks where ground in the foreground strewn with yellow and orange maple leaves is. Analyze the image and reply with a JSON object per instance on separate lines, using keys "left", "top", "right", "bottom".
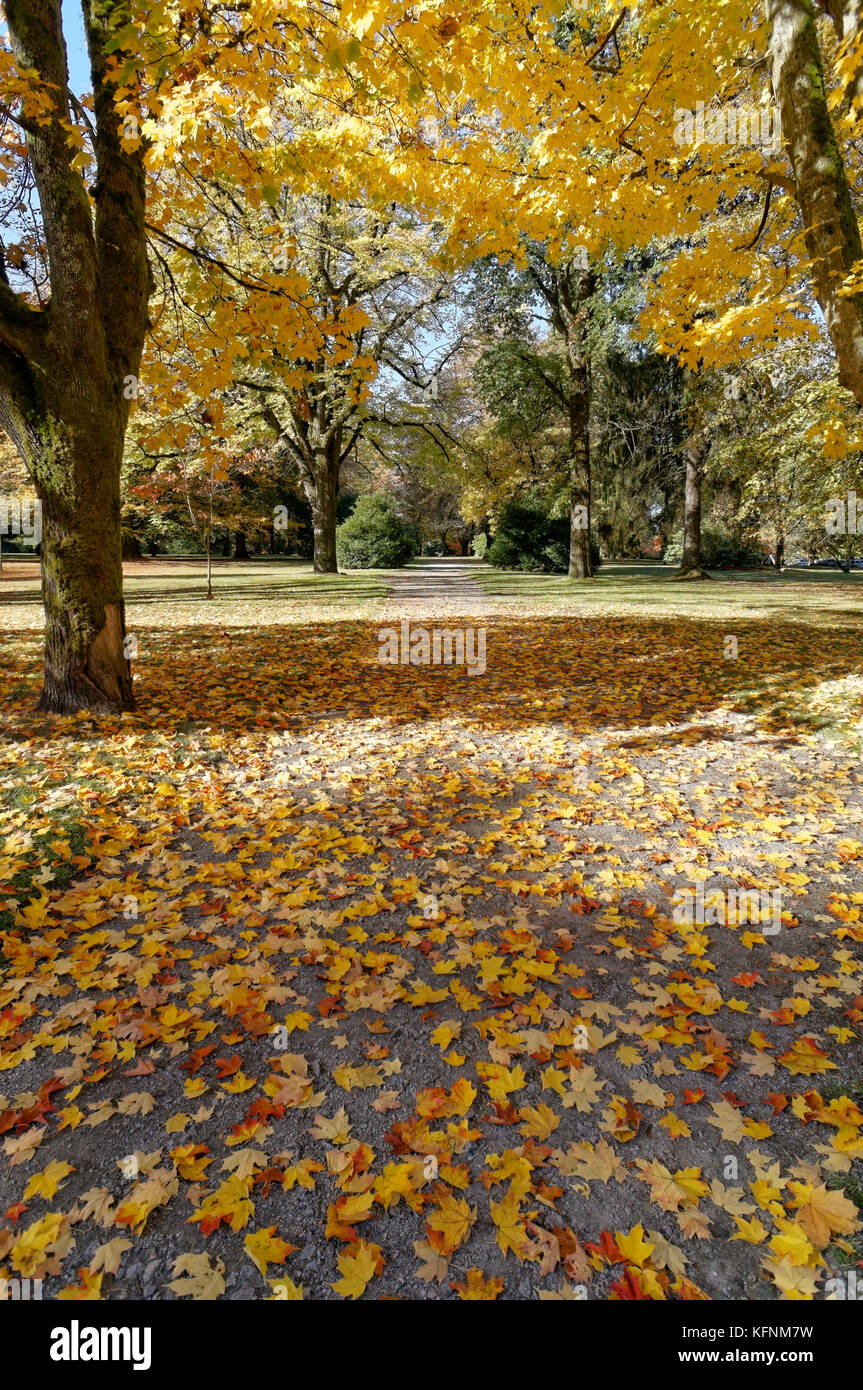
{"left": 0, "top": 558, "right": 863, "bottom": 1298}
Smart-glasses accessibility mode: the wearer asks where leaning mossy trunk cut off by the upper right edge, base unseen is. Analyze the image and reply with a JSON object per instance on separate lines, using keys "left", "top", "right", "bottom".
{"left": 767, "top": 0, "right": 863, "bottom": 406}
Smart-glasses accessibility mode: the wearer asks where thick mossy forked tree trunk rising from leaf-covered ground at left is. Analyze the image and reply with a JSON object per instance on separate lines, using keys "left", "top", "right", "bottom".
{"left": 0, "top": 0, "right": 150, "bottom": 714}
